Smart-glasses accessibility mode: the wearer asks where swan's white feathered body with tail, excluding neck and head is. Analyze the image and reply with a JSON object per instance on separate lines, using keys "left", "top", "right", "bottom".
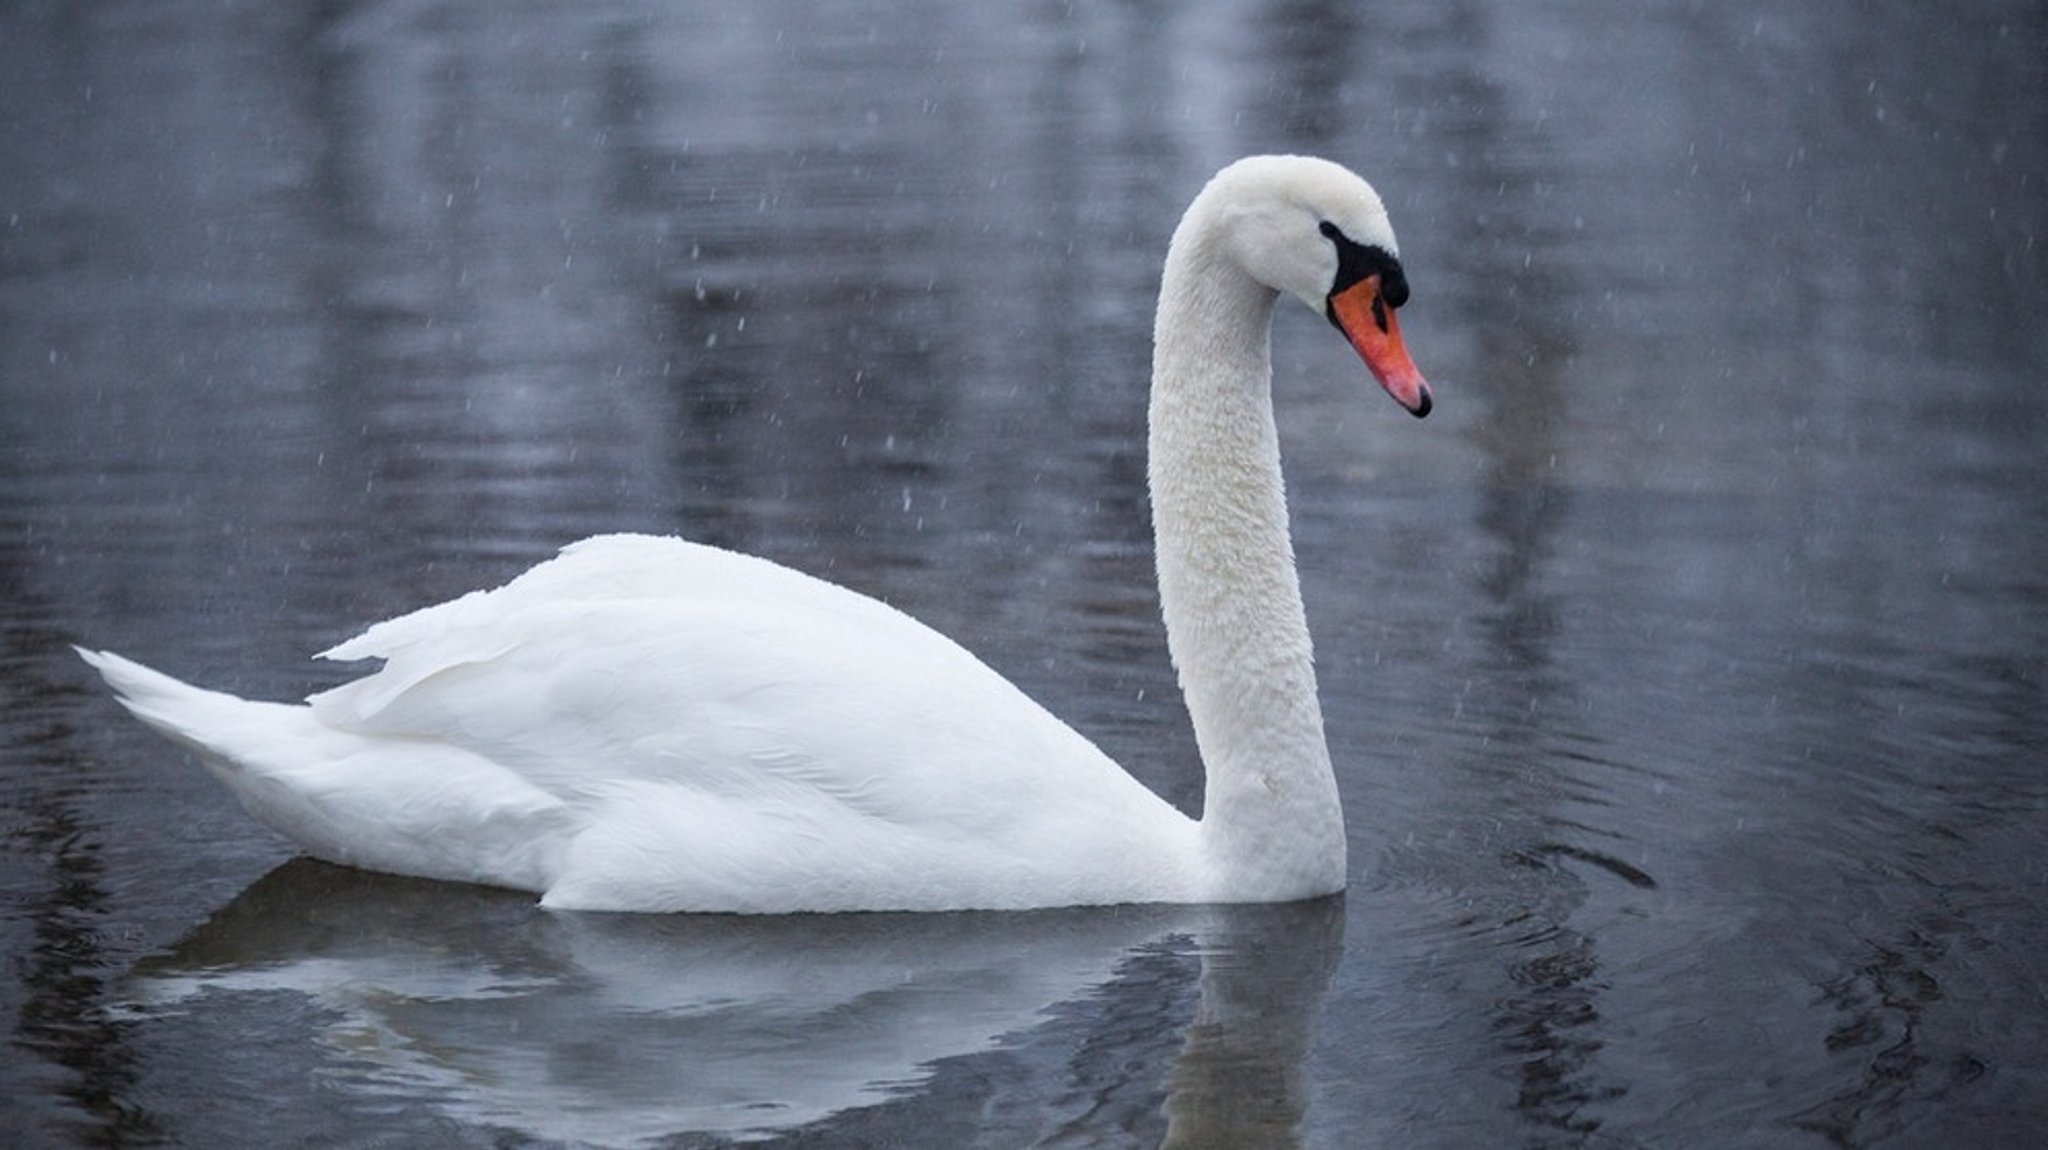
{"left": 92, "top": 536, "right": 1194, "bottom": 913}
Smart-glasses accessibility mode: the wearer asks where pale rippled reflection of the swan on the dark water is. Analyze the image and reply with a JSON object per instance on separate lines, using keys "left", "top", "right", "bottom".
{"left": 133, "top": 859, "right": 1343, "bottom": 1146}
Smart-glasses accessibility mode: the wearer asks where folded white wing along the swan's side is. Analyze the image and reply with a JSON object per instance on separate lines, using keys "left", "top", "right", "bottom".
{"left": 309, "top": 536, "right": 1186, "bottom": 879}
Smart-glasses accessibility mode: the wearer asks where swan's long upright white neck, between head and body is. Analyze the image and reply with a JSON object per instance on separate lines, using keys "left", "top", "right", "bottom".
{"left": 1149, "top": 205, "right": 1346, "bottom": 900}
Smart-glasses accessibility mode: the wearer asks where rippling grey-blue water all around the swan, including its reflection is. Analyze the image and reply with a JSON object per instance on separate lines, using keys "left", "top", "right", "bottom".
{"left": 0, "top": 2, "right": 2048, "bottom": 1148}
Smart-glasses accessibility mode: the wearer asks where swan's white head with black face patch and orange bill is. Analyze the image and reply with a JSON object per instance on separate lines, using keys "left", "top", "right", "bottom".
{"left": 1202, "top": 156, "right": 1430, "bottom": 415}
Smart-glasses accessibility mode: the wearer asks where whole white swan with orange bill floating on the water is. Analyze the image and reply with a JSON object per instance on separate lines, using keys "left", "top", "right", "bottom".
{"left": 80, "top": 156, "right": 1430, "bottom": 913}
